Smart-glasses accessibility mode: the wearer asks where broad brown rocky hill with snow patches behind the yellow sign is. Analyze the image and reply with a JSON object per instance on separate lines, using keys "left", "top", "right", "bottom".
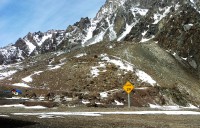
{"left": 1, "top": 42, "right": 200, "bottom": 107}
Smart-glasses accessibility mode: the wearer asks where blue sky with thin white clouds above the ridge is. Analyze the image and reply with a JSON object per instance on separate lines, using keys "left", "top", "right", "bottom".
{"left": 0, "top": 0, "right": 106, "bottom": 47}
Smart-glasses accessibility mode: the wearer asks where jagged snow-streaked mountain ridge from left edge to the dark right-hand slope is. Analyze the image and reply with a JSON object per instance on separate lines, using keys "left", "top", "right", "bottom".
{"left": 0, "top": 0, "right": 148, "bottom": 64}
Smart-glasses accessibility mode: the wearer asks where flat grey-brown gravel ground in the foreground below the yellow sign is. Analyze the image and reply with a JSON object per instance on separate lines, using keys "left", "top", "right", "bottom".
{"left": 0, "top": 107, "right": 200, "bottom": 128}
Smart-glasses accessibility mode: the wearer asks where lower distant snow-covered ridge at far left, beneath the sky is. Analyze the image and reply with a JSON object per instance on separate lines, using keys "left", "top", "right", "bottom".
{"left": 0, "top": 30, "right": 64, "bottom": 64}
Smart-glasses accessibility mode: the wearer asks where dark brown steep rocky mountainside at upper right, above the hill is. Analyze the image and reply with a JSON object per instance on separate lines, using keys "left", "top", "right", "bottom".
{"left": 125, "top": 1, "right": 200, "bottom": 76}
